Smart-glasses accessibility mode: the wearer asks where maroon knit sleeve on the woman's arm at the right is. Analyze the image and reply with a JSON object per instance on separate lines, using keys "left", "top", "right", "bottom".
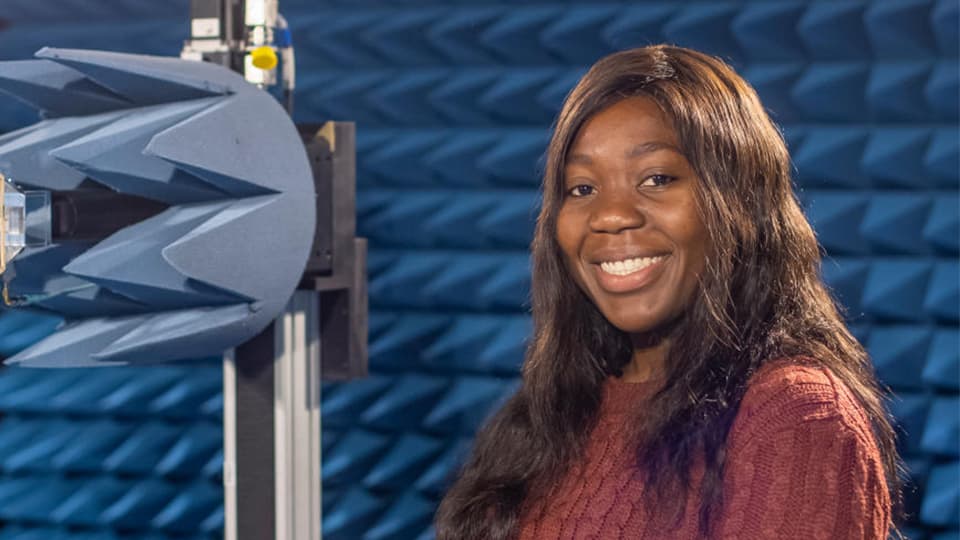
{"left": 718, "top": 365, "right": 890, "bottom": 540}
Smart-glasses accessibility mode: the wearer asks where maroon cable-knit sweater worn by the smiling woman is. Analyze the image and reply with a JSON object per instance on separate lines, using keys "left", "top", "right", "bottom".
{"left": 519, "top": 360, "right": 890, "bottom": 540}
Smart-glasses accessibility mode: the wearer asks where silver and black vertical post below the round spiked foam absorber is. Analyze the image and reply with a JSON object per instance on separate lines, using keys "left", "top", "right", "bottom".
{"left": 223, "top": 291, "right": 322, "bottom": 540}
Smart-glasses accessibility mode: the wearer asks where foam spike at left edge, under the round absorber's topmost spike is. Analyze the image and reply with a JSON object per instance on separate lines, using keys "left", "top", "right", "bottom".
{"left": 0, "top": 60, "right": 132, "bottom": 118}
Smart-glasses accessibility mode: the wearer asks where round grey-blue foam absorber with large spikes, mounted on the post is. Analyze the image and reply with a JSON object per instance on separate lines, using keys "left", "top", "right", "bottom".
{"left": 0, "top": 48, "right": 316, "bottom": 367}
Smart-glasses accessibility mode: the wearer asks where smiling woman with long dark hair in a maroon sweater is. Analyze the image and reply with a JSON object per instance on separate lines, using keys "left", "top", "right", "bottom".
{"left": 436, "top": 46, "right": 900, "bottom": 540}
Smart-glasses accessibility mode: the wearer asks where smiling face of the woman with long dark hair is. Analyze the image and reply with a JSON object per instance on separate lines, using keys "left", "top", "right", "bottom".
{"left": 557, "top": 97, "right": 706, "bottom": 334}
